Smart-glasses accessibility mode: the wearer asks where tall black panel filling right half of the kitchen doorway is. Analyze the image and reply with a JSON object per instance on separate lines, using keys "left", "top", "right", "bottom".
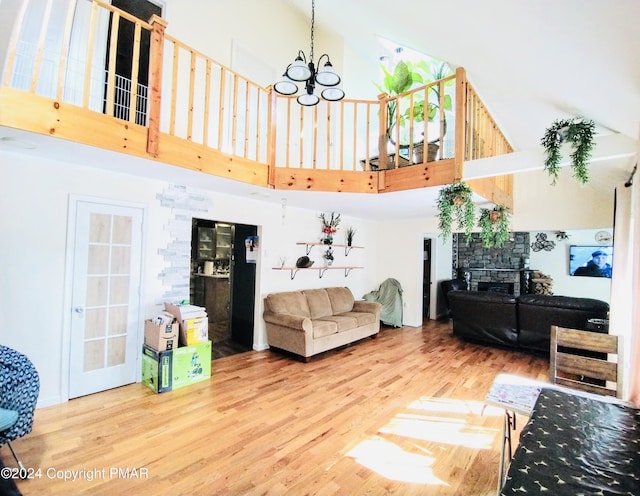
{"left": 231, "top": 224, "right": 259, "bottom": 349}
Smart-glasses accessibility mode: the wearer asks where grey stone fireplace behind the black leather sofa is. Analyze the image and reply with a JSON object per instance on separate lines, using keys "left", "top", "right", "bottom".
{"left": 453, "top": 232, "right": 532, "bottom": 296}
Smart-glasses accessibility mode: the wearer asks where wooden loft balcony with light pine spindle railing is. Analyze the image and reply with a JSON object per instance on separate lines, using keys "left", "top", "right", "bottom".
{"left": 0, "top": 0, "right": 513, "bottom": 207}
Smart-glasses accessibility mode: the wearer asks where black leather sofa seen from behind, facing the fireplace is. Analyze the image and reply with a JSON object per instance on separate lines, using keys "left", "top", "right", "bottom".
{"left": 447, "top": 290, "right": 609, "bottom": 354}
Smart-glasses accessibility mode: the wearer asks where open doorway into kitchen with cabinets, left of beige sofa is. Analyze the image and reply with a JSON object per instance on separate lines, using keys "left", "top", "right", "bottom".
{"left": 190, "top": 218, "right": 258, "bottom": 359}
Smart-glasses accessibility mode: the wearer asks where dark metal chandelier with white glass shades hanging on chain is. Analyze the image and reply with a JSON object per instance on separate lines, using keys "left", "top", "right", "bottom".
{"left": 273, "top": 0, "right": 344, "bottom": 107}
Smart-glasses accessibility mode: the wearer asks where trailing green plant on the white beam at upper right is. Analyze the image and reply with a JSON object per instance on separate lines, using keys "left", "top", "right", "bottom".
{"left": 541, "top": 117, "right": 596, "bottom": 184}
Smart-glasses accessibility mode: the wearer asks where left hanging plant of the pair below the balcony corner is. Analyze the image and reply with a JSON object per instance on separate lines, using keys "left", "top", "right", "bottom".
{"left": 436, "top": 181, "right": 476, "bottom": 240}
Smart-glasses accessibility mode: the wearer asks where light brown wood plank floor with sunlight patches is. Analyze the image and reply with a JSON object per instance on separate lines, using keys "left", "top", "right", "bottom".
{"left": 5, "top": 321, "right": 548, "bottom": 496}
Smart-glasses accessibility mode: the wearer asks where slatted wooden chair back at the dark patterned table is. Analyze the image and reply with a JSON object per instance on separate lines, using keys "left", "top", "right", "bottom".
{"left": 549, "top": 326, "right": 622, "bottom": 398}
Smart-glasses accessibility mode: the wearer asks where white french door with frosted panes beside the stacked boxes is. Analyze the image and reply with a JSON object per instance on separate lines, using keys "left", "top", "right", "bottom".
{"left": 69, "top": 199, "right": 144, "bottom": 398}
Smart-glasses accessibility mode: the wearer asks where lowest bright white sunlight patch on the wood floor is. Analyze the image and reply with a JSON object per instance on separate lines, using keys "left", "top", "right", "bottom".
{"left": 347, "top": 436, "right": 448, "bottom": 486}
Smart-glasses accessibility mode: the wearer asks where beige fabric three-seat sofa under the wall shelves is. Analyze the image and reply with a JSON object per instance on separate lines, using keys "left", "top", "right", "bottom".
{"left": 263, "top": 287, "right": 381, "bottom": 361}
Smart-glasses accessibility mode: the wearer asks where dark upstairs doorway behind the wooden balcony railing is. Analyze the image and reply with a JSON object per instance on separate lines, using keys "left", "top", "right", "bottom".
{"left": 105, "top": 0, "right": 162, "bottom": 126}
